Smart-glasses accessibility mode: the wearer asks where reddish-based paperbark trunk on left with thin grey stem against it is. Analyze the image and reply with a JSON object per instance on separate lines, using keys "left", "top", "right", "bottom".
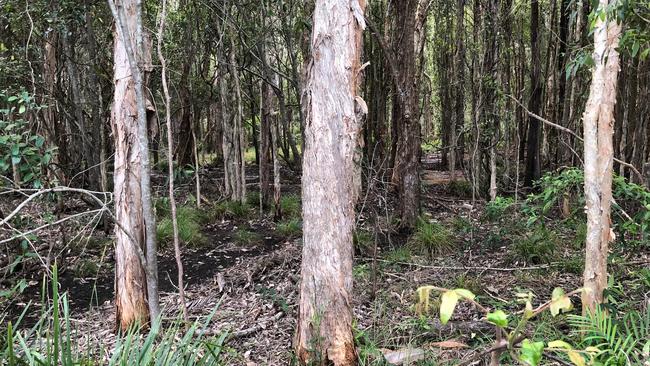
{"left": 108, "top": 0, "right": 160, "bottom": 330}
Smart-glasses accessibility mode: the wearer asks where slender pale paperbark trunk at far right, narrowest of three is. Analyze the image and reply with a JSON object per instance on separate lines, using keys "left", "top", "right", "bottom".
{"left": 582, "top": 0, "right": 621, "bottom": 312}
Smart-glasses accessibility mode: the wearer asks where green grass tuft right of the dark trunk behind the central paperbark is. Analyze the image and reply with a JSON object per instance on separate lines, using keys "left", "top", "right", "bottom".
{"left": 408, "top": 217, "right": 456, "bottom": 257}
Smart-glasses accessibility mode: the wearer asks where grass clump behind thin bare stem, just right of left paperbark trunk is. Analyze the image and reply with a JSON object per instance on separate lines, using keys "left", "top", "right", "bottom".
{"left": 157, "top": 202, "right": 207, "bottom": 246}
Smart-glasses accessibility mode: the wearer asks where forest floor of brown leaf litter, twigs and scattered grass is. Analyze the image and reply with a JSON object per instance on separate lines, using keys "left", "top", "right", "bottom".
{"left": 0, "top": 153, "right": 650, "bottom": 366}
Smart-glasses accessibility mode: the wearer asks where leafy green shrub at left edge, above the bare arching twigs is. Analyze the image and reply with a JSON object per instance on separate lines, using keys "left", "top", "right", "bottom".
{"left": 0, "top": 91, "right": 56, "bottom": 188}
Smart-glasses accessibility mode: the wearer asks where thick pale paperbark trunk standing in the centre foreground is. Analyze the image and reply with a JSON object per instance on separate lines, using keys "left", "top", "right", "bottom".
{"left": 295, "top": 0, "right": 365, "bottom": 365}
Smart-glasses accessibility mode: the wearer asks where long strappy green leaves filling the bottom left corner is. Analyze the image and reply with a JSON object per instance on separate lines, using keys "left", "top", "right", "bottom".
{"left": 0, "top": 266, "right": 227, "bottom": 366}
